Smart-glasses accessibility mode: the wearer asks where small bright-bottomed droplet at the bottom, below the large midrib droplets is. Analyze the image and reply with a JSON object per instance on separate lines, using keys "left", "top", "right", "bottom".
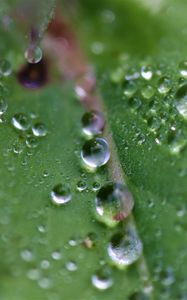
{"left": 91, "top": 267, "right": 114, "bottom": 290}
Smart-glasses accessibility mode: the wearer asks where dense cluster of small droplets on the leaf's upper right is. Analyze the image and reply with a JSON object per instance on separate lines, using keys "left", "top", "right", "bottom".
{"left": 110, "top": 57, "right": 187, "bottom": 155}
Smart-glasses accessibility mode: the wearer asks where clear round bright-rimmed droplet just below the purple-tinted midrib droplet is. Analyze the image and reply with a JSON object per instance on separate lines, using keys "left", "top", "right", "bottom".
{"left": 81, "top": 138, "right": 110, "bottom": 169}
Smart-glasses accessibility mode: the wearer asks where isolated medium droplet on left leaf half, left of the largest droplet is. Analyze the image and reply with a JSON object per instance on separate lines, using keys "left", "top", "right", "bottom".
{"left": 51, "top": 183, "right": 71, "bottom": 205}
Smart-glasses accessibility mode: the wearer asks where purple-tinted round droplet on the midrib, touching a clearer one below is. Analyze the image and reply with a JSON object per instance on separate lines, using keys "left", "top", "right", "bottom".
{"left": 81, "top": 110, "right": 105, "bottom": 136}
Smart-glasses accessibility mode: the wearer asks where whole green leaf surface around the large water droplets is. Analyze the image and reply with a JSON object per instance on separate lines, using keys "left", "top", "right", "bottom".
{"left": 0, "top": 0, "right": 187, "bottom": 300}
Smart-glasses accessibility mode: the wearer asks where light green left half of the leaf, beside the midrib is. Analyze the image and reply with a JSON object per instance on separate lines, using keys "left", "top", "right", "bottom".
{"left": 0, "top": 4, "right": 141, "bottom": 300}
